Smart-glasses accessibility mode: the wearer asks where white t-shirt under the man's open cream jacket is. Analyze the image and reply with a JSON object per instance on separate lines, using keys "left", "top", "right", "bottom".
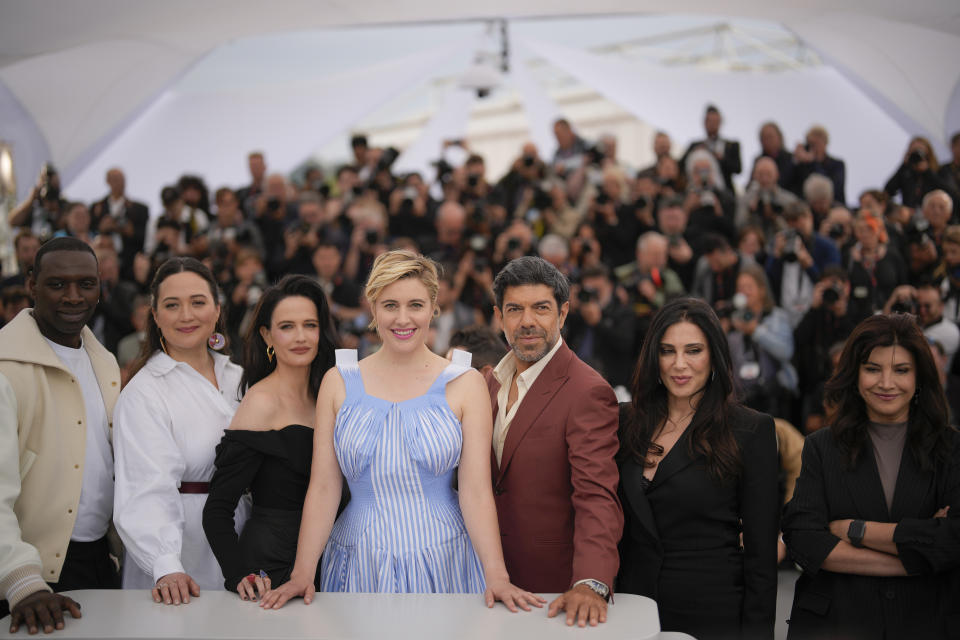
{"left": 44, "top": 338, "right": 113, "bottom": 542}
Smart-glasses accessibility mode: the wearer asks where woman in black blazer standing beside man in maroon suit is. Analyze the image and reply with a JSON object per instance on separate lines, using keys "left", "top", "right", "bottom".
{"left": 617, "top": 298, "right": 779, "bottom": 640}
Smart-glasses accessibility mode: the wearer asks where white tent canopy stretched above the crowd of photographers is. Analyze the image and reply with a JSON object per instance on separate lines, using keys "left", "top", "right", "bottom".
{"left": 0, "top": 0, "right": 960, "bottom": 206}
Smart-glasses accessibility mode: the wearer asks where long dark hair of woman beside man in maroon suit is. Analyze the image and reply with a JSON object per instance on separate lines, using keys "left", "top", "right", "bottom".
{"left": 620, "top": 298, "right": 740, "bottom": 481}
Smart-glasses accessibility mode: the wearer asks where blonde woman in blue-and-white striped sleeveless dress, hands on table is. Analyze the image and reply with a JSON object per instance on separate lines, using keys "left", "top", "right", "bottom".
{"left": 261, "top": 251, "right": 545, "bottom": 611}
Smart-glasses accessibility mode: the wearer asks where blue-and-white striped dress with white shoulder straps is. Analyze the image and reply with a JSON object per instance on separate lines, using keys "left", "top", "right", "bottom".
{"left": 320, "top": 349, "right": 484, "bottom": 593}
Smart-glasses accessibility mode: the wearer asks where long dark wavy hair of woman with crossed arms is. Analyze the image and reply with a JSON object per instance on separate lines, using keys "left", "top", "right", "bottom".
{"left": 824, "top": 313, "right": 951, "bottom": 471}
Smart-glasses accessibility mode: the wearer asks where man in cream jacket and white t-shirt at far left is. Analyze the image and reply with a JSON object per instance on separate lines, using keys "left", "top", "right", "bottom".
{"left": 0, "top": 238, "right": 120, "bottom": 633}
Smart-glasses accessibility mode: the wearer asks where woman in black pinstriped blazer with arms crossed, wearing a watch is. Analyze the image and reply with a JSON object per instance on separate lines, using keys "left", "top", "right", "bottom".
{"left": 783, "top": 314, "right": 960, "bottom": 640}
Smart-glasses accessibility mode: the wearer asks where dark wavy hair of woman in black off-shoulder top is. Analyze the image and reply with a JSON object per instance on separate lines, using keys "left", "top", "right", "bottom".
{"left": 240, "top": 275, "right": 340, "bottom": 398}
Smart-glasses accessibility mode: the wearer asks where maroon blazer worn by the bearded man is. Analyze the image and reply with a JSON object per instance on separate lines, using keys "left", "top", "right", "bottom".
{"left": 487, "top": 344, "right": 623, "bottom": 593}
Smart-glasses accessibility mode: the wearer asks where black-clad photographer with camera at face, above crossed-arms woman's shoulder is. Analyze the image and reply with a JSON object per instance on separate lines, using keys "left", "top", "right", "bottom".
{"left": 793, "top": 265, "right": 857, "bottom": 424}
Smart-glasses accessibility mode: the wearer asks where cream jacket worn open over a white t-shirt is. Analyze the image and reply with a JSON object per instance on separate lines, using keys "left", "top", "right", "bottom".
{"left": 0, "top": 309, "right": 120, "bottom": 608}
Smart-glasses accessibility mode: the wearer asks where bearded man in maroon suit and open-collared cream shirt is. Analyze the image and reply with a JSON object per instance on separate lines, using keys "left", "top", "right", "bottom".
{"left": 488, "top": 256, "right": 623, "bottom": 626}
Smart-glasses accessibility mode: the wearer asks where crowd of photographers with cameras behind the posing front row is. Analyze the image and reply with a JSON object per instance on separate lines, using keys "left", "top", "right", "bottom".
{"left": 0, "top": 107, "right": 960, "bottom": 432}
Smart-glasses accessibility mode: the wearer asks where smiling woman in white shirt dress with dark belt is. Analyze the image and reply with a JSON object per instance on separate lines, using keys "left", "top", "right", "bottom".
{"left": 113, "top": 258, "right": 247, "bottom": 604}
